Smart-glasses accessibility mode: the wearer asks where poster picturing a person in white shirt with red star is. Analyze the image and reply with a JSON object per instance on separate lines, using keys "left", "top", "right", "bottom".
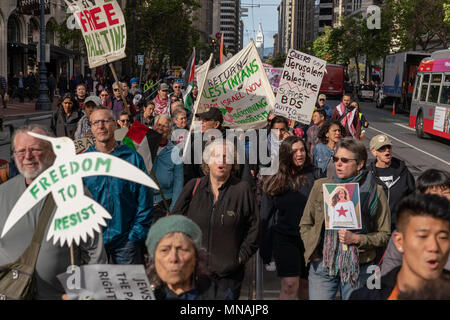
{"left": 322, "top": 183, "right": 362, "bottom": 230}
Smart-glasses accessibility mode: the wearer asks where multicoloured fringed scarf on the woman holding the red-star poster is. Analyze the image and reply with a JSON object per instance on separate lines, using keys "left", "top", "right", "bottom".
{"left": 323, "top": 169, "right": 378, "bottom": 288}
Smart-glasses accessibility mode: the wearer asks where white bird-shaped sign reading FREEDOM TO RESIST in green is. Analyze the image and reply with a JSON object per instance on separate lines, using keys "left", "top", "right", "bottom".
{"left": 1, "top": 132, "right": 159, "bottom": 246}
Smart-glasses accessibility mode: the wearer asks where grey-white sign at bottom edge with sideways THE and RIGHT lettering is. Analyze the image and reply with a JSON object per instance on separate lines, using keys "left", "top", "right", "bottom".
{"left": 57, "top": 264, "right": 155, "bottom": 300}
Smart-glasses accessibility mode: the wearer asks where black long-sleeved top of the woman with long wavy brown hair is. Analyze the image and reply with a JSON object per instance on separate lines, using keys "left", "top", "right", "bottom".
{"left": 259, "top": 167, "right": 314, "bottom": 263}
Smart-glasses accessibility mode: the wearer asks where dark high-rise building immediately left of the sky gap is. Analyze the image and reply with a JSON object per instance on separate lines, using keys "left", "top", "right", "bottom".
{"left": 212, "top": 0, "right": 242, "bottom": 54}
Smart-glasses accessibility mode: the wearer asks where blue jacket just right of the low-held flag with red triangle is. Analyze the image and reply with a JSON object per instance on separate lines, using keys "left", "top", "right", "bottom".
{"left": 153, "top": 141, "right": 184, "bottom": 211}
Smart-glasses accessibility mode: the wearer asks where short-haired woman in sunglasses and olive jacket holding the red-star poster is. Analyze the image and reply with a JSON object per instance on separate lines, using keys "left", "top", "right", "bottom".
{"left": 300, "top": 138, "right": 391, "bottom": 300}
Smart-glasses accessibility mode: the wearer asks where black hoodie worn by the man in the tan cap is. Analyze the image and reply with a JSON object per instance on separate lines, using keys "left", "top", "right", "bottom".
{"left": 369, "top": 157, "right": 415, "bottom": 231}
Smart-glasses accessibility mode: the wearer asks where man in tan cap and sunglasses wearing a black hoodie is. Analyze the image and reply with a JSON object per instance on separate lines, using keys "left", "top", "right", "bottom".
{"left": 369, "top": 134, "right": 415, "bottom": 231}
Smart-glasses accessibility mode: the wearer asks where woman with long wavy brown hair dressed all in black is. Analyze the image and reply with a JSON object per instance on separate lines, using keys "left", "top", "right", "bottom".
{"left": 259, "top": 136, "right": 314, "bottom": 300}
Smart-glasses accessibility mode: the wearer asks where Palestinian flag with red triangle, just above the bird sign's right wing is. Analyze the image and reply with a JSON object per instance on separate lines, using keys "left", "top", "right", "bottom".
{"left": 122, "top": 121, "right": 162, "bottom": 174}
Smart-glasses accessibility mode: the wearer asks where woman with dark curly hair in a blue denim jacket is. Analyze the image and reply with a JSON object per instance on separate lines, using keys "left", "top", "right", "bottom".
{"left": 313, "top": 120, "right": 344, "bottom": 178}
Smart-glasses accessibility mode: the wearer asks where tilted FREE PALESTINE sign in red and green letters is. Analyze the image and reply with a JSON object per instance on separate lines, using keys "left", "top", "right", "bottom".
{"left": 64, "top": 0, "right": 127, "bottom": 69}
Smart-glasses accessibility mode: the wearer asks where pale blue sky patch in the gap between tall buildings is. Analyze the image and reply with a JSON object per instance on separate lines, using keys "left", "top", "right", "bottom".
{"left": 241, "top": 0, "right": 281, "bottom": 48}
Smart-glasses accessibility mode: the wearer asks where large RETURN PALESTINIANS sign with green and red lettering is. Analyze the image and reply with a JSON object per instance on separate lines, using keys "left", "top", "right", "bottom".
{"left": 198, "top": 41, "right": 275, "bottom": 130}
